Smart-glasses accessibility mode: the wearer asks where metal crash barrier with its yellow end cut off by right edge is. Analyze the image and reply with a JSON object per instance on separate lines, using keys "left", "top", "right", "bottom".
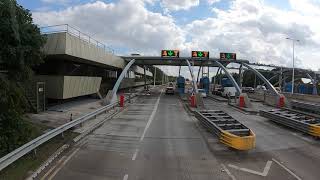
{"left": 260, "top": 109, "right": 320, "bottom": 137}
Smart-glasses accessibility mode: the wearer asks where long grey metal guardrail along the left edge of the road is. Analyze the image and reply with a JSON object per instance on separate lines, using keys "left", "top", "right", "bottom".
{"left": 0, "top": 94, "right": 136, "bottom": 171}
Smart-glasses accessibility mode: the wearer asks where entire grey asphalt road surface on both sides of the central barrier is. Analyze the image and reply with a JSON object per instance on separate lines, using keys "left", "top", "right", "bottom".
{"left": 42, "top": 88, "right": 320, "bottom": 180}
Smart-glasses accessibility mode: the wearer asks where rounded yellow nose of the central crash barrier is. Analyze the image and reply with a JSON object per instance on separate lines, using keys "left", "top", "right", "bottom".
{"left": 220, "top": 130, "right": 256, "bottom": 150}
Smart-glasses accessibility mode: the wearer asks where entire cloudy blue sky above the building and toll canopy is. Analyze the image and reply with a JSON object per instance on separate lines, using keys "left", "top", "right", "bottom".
{"left": 17, "top": 0, "right": 320, "bottom": 75}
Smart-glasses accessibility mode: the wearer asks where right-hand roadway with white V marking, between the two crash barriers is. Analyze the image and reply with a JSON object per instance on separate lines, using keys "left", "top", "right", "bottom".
{"left": 204, "top": 99, "right": 320, "bottom": 180}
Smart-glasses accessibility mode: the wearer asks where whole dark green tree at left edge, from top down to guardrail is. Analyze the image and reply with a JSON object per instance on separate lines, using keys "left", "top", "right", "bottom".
{"left": 0, "top": 0, "right": 45, "bottom": 155}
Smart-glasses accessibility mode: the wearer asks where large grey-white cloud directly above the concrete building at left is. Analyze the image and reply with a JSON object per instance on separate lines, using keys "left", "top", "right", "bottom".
{"left": 33, "top": 0, "right": 185, "bottom": 55}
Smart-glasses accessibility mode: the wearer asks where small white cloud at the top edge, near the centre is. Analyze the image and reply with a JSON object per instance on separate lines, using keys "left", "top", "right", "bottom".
{"left": 161, "top": 0, "right": 200, "bottom": 11}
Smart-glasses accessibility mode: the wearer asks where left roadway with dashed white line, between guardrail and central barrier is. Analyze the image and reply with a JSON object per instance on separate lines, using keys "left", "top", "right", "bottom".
{"left": 43, "top": 89, "right": 229, "bottom": 180}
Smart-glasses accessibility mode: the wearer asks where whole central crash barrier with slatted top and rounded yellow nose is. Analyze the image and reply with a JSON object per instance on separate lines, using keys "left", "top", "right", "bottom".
{"left": 195, "top": 110, "right": 256, "bottom": 150}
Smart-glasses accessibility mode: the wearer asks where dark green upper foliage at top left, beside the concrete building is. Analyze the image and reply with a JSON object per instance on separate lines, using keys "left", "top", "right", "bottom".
{"left": 0, "top": 0, "right": 45, "bottom": 81}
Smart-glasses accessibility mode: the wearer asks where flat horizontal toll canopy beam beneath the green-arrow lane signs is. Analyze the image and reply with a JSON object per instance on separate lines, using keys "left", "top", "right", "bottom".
{"left": 122, "top": 56, "right": 249, "bottom": 67}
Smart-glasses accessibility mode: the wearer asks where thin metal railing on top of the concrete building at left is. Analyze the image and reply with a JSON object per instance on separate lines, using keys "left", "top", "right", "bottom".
{"left": 40, "top": 24, "right": 114, "bottom": 54}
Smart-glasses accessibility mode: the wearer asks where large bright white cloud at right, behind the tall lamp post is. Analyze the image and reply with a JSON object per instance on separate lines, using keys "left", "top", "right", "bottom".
{"left": 185, "top": 0, "right": 320, "bottom": 68}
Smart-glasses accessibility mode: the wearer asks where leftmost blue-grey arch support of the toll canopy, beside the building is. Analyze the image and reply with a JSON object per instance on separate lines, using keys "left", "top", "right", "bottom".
{"left": 106, "top": 59, "right": 136, "bottom": 104}
